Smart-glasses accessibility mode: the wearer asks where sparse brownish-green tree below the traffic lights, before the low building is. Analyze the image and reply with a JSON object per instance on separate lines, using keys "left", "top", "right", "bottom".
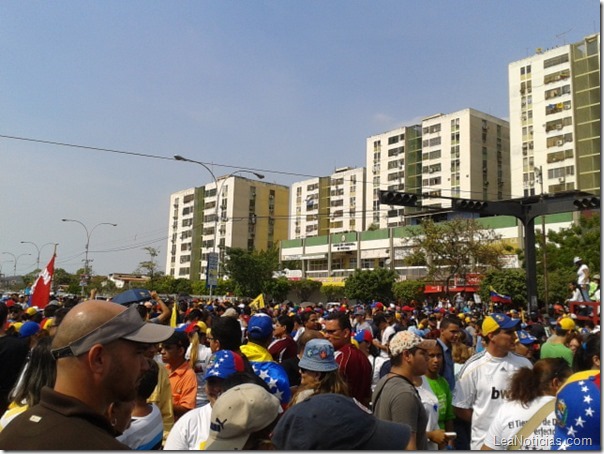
{"left": 407, "top": 218, "right": 505, "bottom": 287}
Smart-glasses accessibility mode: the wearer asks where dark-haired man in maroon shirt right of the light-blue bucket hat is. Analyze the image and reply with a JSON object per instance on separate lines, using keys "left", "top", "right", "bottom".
{"left": 323, "top": 313, "right": 372, "bottom": 407}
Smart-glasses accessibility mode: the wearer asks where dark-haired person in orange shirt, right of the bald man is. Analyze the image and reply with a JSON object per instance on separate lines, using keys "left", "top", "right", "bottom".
{"left": 160, "top": 331, "right": 197, "bottom": 421}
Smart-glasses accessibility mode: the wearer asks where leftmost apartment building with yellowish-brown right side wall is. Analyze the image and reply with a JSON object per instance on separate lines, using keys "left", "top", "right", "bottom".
{"left": 166, "top": 175, "right": 289, "bottom": 280}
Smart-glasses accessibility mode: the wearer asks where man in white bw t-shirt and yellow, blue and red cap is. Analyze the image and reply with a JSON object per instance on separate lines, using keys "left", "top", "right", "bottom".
{"left": 453, "top": 313, "right": 533, "bottom": 450}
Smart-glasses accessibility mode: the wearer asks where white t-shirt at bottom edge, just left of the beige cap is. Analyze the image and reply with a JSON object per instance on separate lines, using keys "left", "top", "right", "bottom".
{"left": 164, "top": 404, "right": 212, "bottom": 451}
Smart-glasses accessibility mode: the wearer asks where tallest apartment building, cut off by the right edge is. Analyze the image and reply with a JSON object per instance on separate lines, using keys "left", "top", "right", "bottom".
{"left": 508, "top": 33, "right": 601, "bottom": 197}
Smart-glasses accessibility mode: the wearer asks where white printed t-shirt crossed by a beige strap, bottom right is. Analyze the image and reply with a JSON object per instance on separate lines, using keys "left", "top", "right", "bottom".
{"left": 484, "top": 396, "right": 556, "bottom": 451}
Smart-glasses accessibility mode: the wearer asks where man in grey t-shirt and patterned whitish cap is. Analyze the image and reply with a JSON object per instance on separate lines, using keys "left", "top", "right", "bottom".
{"left": 372, "top": 331, "right": 436, "bottom": 450}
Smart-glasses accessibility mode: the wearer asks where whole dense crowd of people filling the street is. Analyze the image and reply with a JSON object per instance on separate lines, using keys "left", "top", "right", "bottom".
{"left": 0, "top": 292, "right": 600, "bottom": 450}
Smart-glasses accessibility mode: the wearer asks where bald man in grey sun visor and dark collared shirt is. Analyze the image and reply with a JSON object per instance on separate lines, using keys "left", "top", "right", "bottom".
{"left": 0, "top": 300, "right": 173, "bottom": 450}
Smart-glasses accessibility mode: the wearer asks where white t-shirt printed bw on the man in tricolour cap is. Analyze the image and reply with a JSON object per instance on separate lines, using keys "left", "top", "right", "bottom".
{"left": 453, "top": 350, "right": 533, "bottom": 450}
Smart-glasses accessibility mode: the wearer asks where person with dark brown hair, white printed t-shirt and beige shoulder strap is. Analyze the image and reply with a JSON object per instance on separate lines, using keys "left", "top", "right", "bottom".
{"left": 482, "top": 358, "right": 572, "bottom": 451}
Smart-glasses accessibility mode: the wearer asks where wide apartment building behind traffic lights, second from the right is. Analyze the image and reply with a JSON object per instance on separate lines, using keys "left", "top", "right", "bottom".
{"left": 366, "top": 109, "right": 511, "bottom": 228}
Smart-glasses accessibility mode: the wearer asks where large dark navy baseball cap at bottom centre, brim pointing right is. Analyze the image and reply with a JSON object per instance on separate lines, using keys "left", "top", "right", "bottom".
{"left": 272, "top": 393, "right": 411, "bottom": 451}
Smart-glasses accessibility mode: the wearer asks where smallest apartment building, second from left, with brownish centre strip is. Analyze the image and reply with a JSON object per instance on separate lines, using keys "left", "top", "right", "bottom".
{"left": 289, "top": 167, "right": 365, "bottom": 238}
